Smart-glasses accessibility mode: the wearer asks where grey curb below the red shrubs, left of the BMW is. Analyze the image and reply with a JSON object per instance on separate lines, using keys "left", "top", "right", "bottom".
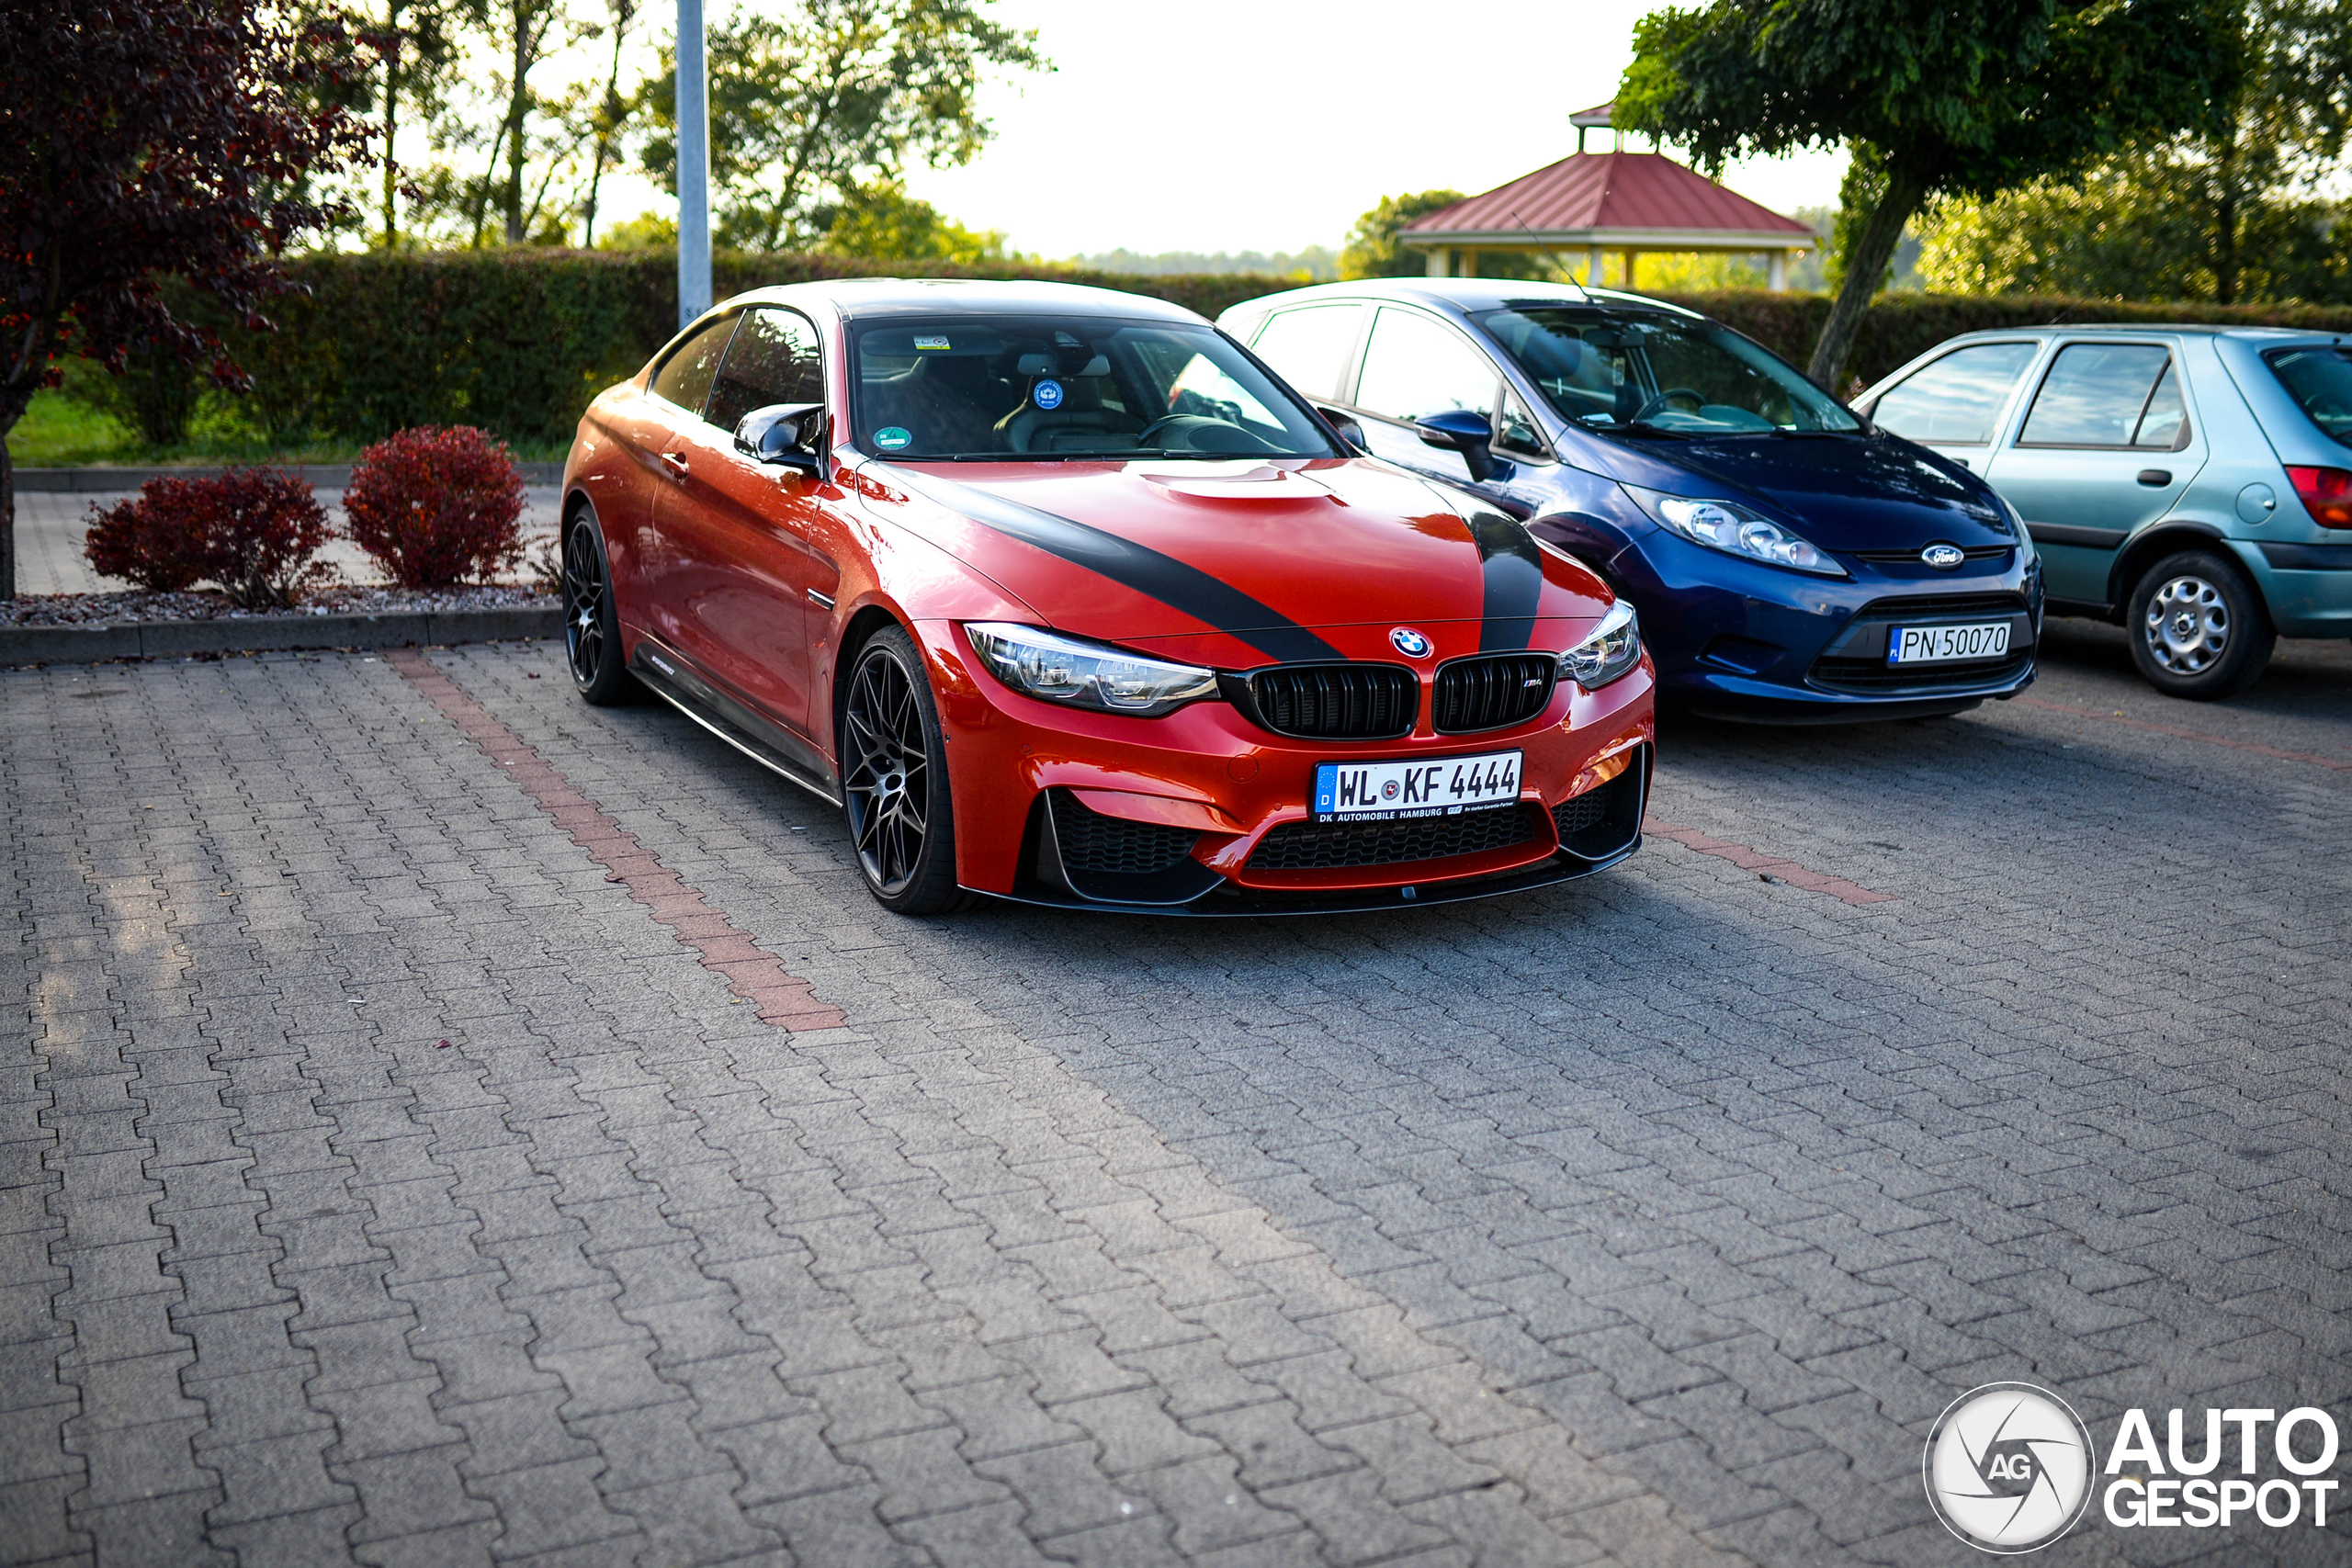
{"left": 0, "top": 604, "right": 564, "bottom": 665}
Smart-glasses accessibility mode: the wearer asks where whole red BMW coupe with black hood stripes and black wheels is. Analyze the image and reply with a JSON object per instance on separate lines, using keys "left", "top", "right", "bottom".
{"left": 562, "top": 280, "right": 1654, "bottom": 915}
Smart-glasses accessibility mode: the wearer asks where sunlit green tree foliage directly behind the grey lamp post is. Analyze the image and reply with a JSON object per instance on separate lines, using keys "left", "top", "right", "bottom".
{"left": 644, "top": 0, "right": 1051, "bottom": 249}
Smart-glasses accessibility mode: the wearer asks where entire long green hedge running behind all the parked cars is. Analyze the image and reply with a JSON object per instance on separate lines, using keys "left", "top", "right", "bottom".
{"left": 207, "top": 249, "right": 2352, "bottom": 446}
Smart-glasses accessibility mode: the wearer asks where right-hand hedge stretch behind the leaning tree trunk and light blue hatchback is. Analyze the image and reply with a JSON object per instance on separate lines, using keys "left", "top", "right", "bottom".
{"left": 1665, "top": 289, "right": 2352, "bottom": 386}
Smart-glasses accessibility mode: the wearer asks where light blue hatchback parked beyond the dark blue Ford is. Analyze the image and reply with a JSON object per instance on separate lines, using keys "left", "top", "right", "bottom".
{"left": 1856, "top": 327, "right": 2352, "bottom": 698}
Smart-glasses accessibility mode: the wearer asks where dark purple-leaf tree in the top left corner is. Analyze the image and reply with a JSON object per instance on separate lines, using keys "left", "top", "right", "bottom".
{"left": 0, "top": 0, "right": 367, "bottom": 600}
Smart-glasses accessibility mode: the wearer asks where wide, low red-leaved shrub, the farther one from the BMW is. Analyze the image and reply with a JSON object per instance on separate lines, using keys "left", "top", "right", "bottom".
{"left": 83, "top": 468, "right": 332, "bottom": 609}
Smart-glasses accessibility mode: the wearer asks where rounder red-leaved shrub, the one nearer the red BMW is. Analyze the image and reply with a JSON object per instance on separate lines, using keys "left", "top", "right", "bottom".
{"left": 344, "top": 425, "right": 522, "bottom": 588}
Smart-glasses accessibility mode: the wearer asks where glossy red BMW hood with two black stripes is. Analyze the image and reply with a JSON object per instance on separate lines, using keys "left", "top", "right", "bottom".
{"left": 856, "top": 458, "right": 1609, "bottom": 668}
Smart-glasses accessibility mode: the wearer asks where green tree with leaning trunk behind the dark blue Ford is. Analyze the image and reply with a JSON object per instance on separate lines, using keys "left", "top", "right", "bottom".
{"left": 1616, "top": 0, "right": 2237, "bottom": 386}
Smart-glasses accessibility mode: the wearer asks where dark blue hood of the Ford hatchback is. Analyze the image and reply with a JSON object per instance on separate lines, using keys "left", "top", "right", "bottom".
{"left": 1601, "top": 434, "right": 2016, "bottom": 550}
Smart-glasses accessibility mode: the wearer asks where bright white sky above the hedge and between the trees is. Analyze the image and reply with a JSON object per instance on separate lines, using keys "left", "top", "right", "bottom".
{"left": 582, "top": 0, "right": 1844, "bottom": 256}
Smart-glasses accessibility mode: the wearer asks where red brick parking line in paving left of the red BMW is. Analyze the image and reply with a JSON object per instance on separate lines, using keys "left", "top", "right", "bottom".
{"left": 386, "top": 649, "right": 844, "bottom": 1030}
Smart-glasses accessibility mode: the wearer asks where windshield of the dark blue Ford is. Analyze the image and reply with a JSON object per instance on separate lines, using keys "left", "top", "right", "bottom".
{"left": 1477, "top": 306, "right": 1863, "bottom": 434}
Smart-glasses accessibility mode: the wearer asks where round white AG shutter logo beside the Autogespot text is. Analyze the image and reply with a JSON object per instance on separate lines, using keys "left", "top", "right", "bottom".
{"left": 1922, "top": 1382, "right": 2093, "bottom": 1556}
